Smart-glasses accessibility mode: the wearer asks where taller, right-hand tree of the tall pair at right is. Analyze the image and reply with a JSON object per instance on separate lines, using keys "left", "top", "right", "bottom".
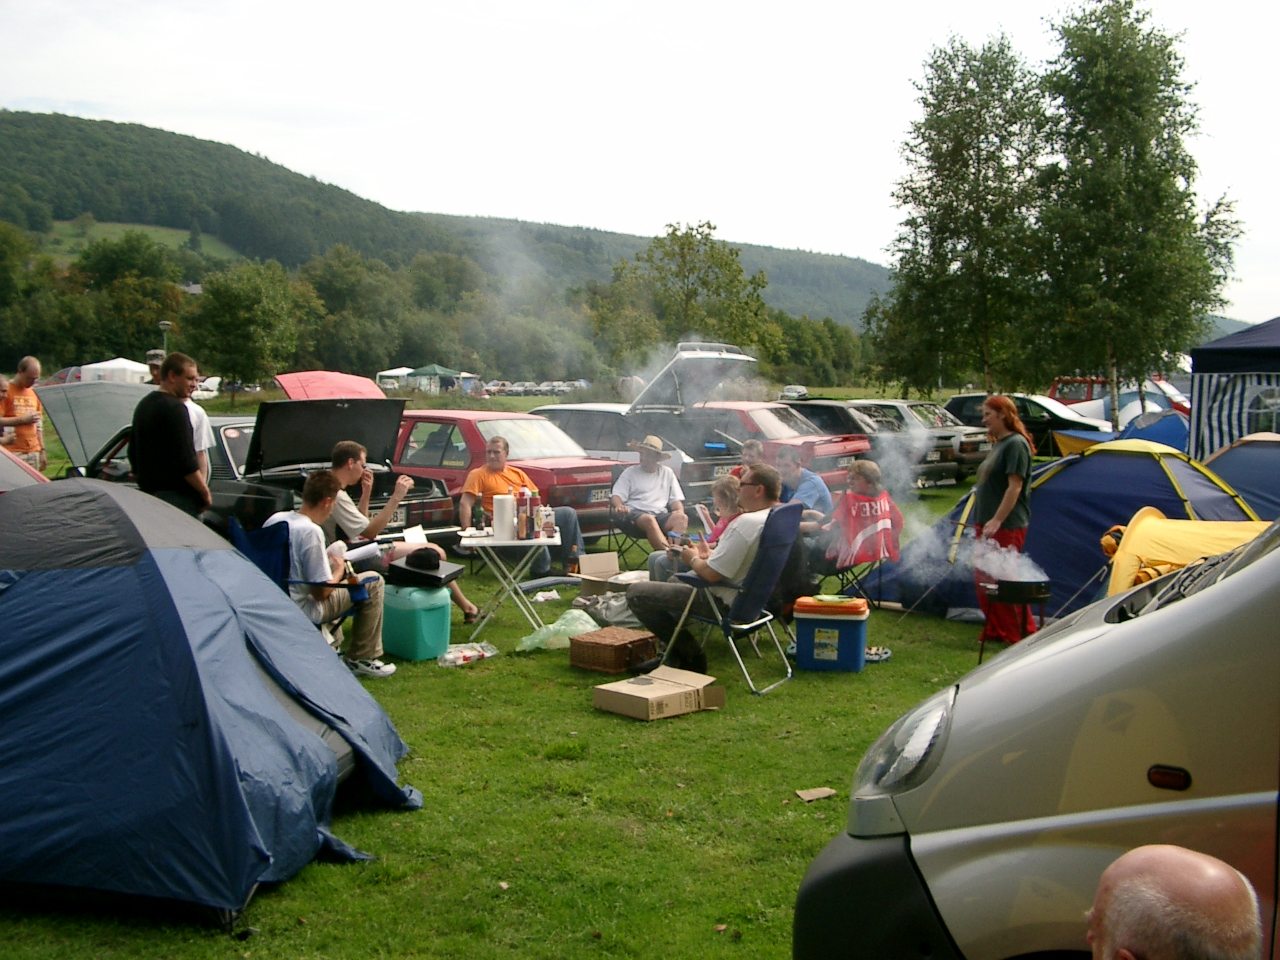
{"left": 1042, "top": 0, "right": 1239, "bottom": 416}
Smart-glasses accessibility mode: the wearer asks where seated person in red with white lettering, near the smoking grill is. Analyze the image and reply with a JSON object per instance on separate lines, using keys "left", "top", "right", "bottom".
{"left": 813, "top": 460, "right": 902, "bottom": 584}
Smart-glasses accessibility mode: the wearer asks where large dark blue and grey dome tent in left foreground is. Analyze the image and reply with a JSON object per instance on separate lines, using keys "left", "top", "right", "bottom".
{"left": 0, "top": 480, "right": 421, "bottom": 910}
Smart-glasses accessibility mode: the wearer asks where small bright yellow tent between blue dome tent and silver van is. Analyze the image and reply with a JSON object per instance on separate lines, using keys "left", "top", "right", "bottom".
{"left": 1107, "top": 507, "right": 1271, "bottom": 596}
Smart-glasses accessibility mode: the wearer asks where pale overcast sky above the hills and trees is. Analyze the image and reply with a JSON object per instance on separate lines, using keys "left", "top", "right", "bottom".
{"left": 0, "top": 0, "right": 1280, "bottom": 323}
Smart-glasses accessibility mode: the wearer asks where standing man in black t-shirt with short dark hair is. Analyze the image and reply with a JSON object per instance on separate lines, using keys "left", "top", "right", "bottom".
{"left": 129, "top": 353, "right": 212, "bottom": 517}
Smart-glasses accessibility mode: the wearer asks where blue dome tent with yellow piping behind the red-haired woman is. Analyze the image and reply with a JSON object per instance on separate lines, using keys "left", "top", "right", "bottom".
{"left": 861, "top": 440, "right": 1257, "bottom": 616}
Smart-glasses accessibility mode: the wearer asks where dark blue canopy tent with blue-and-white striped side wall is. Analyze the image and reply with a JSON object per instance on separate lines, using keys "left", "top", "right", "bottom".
{"left": 1187, "top": 316, "right": 1280, "bottom": 460}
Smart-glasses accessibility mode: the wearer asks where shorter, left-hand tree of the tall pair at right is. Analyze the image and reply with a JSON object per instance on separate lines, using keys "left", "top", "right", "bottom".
{"left": 864, "top": 37, "right": 1044, "bottom": 393}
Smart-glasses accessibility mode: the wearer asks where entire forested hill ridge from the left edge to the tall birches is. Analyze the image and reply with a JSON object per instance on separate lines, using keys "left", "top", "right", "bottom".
{"left": 0, "top": 110, "right": 888, "bottom": 326}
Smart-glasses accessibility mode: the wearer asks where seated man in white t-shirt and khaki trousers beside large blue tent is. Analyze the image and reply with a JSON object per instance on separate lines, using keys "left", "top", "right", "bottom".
{"left": 262, "top": 470, "right": 396, "bottom": 677}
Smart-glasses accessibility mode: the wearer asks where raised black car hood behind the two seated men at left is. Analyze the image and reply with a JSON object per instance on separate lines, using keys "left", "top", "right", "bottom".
{"left": 244, "top": 397, "right": 404, "bottom": 474}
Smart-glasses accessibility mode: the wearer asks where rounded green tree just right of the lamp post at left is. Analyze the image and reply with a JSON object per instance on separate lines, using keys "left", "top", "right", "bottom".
{"left": 182, "top": 260, "right": 323, "bottom": 401}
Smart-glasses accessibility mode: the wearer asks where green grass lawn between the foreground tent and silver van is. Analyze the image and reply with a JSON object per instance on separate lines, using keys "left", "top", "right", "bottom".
{"left": 12, "top": 414, "right": 977, "bottom": 960}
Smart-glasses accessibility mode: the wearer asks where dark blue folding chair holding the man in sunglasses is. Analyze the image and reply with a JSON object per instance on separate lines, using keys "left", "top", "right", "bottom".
{"left": 663, "top": 503, "right": 804, "bottom": 696}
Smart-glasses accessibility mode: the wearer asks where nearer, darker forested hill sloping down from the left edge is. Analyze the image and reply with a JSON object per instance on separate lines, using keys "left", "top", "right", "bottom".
{"left": 0, "top": 110, "right": 461, "bottom": 266}
